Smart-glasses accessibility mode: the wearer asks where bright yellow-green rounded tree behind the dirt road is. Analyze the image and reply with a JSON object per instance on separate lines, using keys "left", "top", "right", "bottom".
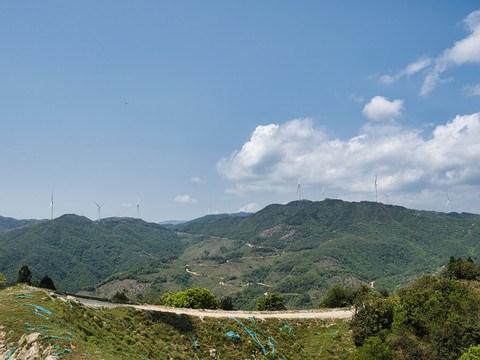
{"left": 161, "top": 288, "right": 218, "bottom": 309}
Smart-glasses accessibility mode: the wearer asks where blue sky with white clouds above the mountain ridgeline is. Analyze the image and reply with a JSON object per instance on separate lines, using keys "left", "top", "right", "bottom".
{"left": 0, "top": 0, "right": 480, "bottom": 222}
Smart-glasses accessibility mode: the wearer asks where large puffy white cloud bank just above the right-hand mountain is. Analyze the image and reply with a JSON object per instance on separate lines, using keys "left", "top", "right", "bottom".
{"left": 217, "top": 113, "right": 480, "bottom": 202}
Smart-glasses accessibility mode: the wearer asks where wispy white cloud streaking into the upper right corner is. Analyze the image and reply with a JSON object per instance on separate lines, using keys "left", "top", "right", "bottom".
{"left": 379, "top": 10, "right": 480, "bottom": 96}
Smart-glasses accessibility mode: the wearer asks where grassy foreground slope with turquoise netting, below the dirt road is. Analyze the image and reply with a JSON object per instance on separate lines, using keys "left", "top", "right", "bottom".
{"left": 0, "top": 285, "right": 354, "bottom": 360}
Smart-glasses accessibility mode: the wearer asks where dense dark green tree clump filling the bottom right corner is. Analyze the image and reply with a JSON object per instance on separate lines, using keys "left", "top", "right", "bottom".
{"left": 352, "top": 276, "right": 480, "bottom": 360}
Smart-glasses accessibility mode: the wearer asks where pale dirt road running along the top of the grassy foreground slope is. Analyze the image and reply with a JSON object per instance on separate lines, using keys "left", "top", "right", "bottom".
{"left": 62, "top": 296, "right": 353, "bottom": 319}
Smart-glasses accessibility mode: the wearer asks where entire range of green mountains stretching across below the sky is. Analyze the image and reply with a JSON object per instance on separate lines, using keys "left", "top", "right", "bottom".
{"left": 0, "top": 199, "right": 480, "bottom": 309}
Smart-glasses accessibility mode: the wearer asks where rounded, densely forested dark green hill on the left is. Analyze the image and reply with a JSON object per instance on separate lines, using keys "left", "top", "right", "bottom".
{"left": 0, "top": 215, "right": 183, "bottom": 292}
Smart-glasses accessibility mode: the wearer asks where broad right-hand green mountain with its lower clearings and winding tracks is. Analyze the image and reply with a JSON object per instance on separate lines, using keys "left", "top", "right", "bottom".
{"left": 89, "top": 200, "right": 480, "bottom": 309}
